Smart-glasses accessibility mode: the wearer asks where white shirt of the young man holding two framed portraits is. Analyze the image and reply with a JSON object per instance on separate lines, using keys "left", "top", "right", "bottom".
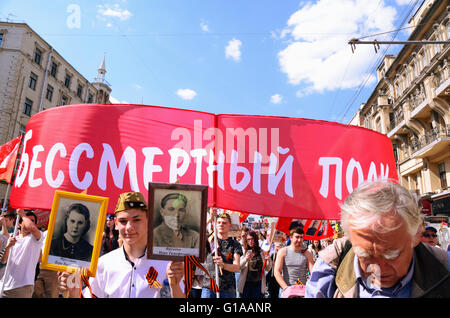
{"left": 83, "top": 247, "right": 169, "bottom": 298}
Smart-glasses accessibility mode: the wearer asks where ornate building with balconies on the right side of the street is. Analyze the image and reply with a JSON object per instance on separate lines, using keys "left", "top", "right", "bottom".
{"left": 350, "top": 0, "right": 450, "bottom": 215}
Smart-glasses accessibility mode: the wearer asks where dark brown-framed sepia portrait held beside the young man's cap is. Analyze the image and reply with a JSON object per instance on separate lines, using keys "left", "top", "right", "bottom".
{"left": 147, "top": 182, "right": 208, "bottom": 262}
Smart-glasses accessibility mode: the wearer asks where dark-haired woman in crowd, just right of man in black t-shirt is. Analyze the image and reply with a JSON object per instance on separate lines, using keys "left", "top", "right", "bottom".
{"left": 238, "top": 231, "right": 272, "bottom": 298}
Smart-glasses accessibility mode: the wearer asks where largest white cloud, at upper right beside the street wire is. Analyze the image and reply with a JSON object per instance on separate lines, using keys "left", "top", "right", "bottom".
{"left": 278, "top": 0, "right": 396, "bottom": 97}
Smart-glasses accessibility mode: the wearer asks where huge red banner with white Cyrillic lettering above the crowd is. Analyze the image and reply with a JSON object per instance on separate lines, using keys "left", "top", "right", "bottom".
{"left": 11, "top": 104, "right": 397, "bottom": 220}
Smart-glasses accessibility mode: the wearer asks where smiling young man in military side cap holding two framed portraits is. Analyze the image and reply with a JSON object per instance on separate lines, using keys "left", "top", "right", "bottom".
{"left": 58, "top": 192, "right": 184, "bottom": 298}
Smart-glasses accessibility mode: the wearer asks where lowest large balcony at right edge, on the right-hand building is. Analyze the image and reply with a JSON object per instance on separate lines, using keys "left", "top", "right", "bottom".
{"left": 411, "top": 125, "right": 450, "bottom": 158}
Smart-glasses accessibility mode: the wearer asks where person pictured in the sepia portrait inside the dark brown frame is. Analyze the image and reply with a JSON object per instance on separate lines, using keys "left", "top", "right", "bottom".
{"left": 153, "top": 193, "right": 200, "bottom": 248}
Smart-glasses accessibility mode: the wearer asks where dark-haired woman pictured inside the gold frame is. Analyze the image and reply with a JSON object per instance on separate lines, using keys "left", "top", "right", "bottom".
{"left": 50, "top": 203, "right": 93, "bottom": 262}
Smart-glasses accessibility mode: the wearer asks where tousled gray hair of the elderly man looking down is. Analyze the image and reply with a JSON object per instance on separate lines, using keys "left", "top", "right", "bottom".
{"left": 341, "top": 181, "right": 422, "bottom": 237}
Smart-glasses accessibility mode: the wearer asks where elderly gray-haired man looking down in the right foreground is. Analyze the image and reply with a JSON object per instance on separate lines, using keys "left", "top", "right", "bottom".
{"left": 305, "top": 181, "right": 450, "bottom": 298}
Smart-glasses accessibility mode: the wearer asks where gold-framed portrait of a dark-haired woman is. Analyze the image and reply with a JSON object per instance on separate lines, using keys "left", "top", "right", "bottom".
{"left": 41, "top": 190, "right": 108, "bottom": 277}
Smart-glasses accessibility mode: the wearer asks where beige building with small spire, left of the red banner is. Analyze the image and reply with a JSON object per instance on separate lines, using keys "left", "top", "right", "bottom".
{"left": 0, "top": 22, "right": 111, "bottom": 206}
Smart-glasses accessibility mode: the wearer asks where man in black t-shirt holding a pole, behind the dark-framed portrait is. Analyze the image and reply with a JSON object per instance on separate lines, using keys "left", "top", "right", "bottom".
{"left": 202, "top": 209, "right": 243, "bottom": 298}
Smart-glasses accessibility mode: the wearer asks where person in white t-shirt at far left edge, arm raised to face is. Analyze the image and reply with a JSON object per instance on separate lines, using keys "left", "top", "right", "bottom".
{"left": 1, "top": 209, "right": 44, "bottom": 298}
